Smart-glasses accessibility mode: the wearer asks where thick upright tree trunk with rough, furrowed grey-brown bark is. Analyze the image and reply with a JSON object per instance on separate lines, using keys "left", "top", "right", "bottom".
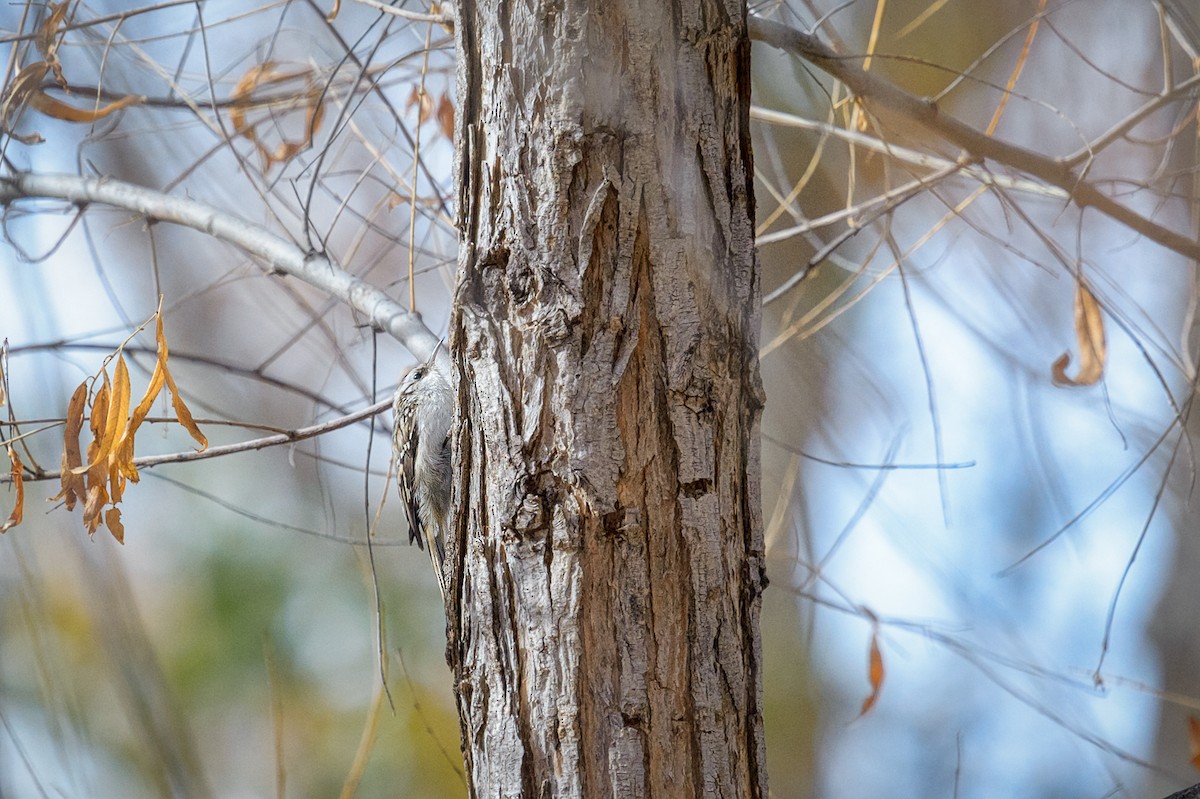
{"left": 448, "top": 0, "right": 767, "bottom": 798}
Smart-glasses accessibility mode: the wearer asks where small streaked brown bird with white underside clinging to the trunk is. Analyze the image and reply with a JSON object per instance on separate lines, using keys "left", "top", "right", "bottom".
{"left": 391, "top": 350, "right": 454, "bottom": 601}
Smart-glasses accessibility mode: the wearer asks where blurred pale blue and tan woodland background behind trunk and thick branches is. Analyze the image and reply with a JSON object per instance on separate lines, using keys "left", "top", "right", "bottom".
{"left": 0, "top": 0, "right": 1200, "bottom": 798}
